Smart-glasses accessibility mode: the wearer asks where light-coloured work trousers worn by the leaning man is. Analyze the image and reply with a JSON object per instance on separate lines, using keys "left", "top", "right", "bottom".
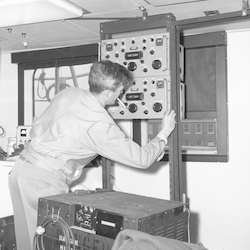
{"left": 9, "top": 158, "right": 69, "bottom": 250}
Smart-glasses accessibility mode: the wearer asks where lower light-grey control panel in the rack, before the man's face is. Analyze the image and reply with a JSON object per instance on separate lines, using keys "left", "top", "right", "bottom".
{"left": 108, "top": 76, "right": 170, "bottom": 119}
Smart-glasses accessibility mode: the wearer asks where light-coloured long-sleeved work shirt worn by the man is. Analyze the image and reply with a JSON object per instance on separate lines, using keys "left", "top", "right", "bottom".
{"left": 29, "top": 87, "right": 165, "bottom": 183}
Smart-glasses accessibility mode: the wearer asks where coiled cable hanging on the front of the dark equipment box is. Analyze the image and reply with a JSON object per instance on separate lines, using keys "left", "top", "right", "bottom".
{"left": 33, "top": 213, "right": 75, "bottom": 250}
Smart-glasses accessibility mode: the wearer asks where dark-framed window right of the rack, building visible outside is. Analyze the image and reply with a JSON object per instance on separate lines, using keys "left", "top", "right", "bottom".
{"left": 180, "top": 32, "right": 228, "bottom": 162}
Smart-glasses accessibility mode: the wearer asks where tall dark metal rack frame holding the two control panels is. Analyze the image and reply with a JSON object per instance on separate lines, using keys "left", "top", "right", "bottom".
{"left": 100, "top": 13, "right": 184, "bottom": 201}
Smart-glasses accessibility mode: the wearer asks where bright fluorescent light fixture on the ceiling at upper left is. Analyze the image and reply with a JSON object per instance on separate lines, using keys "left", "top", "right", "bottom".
{"left": 0, "top": 0, "right": 87, "bottom": 27}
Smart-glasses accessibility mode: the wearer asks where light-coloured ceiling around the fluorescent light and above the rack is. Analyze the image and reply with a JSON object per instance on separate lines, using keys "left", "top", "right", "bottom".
{"left": 0, "top": 0, "right": 250, "bottom": 53}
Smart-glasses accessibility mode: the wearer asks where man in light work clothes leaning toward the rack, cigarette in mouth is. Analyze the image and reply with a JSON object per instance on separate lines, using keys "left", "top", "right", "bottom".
{"left": 9, "top": 60, "right": 175, "bottom": 250}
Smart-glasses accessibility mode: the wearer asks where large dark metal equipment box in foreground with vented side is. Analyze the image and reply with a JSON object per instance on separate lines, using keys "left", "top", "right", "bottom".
{"left": 34, "top": 189, "right": 189, "bottom": 250}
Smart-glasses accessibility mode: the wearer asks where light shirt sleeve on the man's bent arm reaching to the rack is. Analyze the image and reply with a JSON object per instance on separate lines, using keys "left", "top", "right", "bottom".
{"left": 88, "top": 122, "right": 165, "bottom": 168}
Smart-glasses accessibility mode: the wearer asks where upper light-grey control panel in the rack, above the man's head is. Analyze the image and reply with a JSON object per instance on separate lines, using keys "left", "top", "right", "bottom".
{"left": 101, "top": 33, "right": 170, "bottom": 77}
